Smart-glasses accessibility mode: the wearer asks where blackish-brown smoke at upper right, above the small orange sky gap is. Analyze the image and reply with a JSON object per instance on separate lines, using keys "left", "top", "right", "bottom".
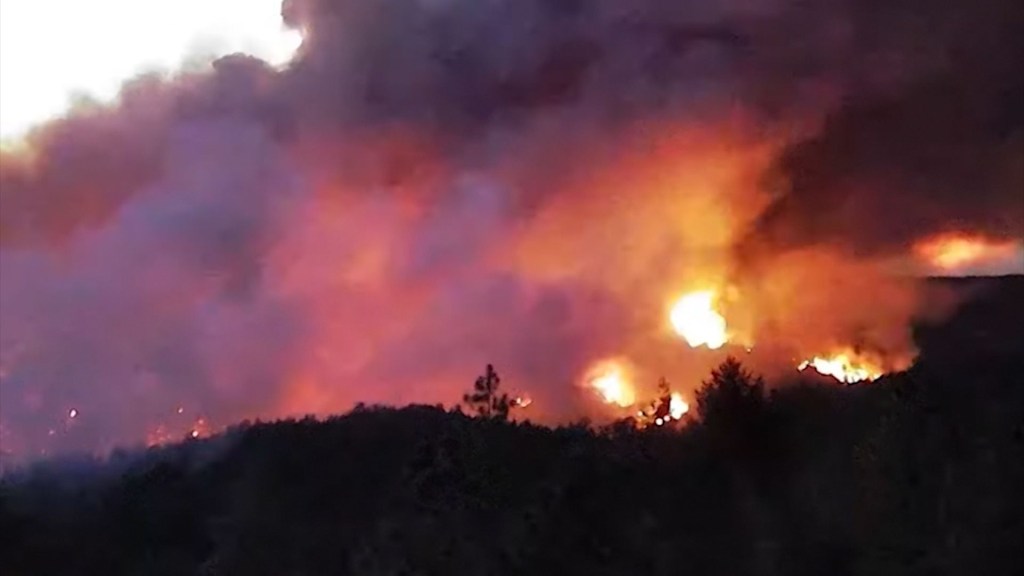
{"left": 743, "top": 0, "right": 1024, "bottom": 253}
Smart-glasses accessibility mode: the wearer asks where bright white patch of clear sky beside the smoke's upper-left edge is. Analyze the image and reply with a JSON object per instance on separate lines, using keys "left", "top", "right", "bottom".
{"left": 0, "top": 0, "right": 301, "bottom": 139}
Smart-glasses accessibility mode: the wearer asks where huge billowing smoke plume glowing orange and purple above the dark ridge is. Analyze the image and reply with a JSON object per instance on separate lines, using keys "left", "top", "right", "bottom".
{"left": 0, "top": 0, "right": 1024, "bottom": 451}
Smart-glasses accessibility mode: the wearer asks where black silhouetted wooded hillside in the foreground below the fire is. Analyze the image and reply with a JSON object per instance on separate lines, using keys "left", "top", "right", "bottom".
{"left": 0, "top": 278, "right": 1024, "bottom": 576}
